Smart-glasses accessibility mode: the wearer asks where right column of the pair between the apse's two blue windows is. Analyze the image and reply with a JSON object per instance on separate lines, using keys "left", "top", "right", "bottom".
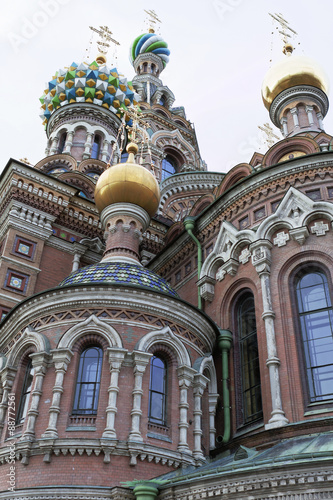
{"left": 128, "top": 351, "right": 152, "bottom": 442}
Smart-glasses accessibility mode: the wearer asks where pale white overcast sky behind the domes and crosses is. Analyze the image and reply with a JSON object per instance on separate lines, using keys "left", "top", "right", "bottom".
{"left": 0, "top": 0, "right": 333, "bottom": 172}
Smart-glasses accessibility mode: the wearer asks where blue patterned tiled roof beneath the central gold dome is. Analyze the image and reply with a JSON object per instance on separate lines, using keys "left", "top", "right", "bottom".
{"left": 59, "top": 262, "right": 178, "bottom": 297}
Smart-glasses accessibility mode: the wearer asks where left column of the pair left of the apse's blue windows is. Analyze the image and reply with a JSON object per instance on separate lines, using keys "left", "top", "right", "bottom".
{"left": 21, "top": 352, "right": 51, "bottom": 441}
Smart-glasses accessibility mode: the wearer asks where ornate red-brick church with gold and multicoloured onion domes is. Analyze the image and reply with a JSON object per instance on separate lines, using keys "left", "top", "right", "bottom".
{"left": 0, "top": 15, "right": 333, "bottom": 500}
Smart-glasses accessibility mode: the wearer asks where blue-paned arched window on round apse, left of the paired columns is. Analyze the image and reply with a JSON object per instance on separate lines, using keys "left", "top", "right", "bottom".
{"left": 72, "top": 347, "right": 103, "bottom": 415}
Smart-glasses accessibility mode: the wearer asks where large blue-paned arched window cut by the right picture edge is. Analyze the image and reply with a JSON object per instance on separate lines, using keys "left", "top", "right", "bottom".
{"left": 296, "top": 270, "right": 333, "bottom": 402}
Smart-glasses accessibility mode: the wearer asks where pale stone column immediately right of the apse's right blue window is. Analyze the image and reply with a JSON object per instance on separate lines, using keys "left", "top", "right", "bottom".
{"left": 177, "top": 366, "right": 197, "bottom": 454}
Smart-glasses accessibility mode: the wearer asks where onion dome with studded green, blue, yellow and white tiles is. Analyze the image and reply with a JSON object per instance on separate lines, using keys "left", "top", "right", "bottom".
{"left": 40, "top": 61, "right": 138, "bottom": 125}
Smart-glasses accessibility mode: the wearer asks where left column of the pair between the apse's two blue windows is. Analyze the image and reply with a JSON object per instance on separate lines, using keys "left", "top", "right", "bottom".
{"left": 102, "top": 347, "right": 127, "bottom": 439}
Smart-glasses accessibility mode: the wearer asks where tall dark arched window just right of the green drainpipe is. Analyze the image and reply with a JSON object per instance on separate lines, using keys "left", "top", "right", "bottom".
{"left": 237, "top": 292, "right": 262, "bottom": 424}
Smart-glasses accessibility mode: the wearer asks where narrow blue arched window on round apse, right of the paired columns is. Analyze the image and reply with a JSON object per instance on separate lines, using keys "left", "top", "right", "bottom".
{"left": 148, "top": 356, "right": 167, "bottom": 425}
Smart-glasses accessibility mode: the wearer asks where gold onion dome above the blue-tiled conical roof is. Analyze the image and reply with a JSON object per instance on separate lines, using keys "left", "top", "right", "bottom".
{"left": 95, "top": 143, "right": 160, "bottom": 217}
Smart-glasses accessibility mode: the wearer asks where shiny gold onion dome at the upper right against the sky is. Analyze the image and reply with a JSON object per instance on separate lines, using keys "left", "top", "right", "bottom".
{"left": 261, "top": 45, "right": 329, "bottom": 110}
